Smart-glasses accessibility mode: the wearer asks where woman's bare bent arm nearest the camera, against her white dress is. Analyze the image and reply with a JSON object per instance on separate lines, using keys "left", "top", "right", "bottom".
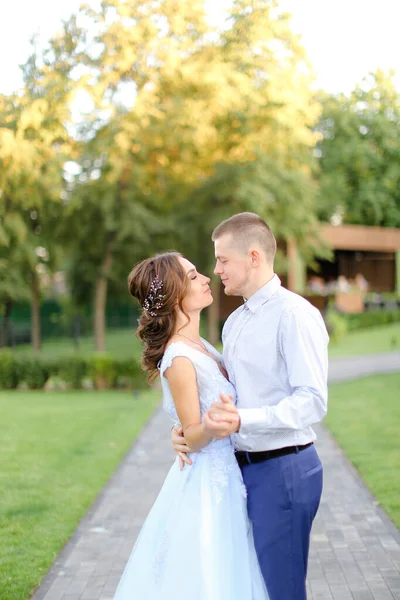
{"left": 164, "top": 356, "right": 213, "bottom": 452}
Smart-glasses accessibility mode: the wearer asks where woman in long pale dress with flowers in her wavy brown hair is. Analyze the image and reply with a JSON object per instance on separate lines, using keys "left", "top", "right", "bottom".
{"left": 115, "top": 252, "right": 268, "bottom": 600}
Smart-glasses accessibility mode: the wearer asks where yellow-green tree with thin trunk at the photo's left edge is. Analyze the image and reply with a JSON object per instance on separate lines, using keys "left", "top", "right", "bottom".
{"left": 0, "top": 36, "right": 73, "bottom": 350}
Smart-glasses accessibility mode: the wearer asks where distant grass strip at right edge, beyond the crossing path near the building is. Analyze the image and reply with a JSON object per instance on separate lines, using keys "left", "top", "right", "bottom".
{"left": 329, "top": 323, "right": 400, "bottom": 358}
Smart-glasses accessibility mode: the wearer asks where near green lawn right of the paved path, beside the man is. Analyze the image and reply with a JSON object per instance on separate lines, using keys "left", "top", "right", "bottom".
{"left": 325, "top": 372, "right": 400, "bottom": 527}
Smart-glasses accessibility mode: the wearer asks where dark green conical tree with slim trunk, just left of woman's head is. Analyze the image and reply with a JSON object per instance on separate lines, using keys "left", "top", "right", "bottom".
{"left": 59, "top": 121, "right": 157, "bottom": 352}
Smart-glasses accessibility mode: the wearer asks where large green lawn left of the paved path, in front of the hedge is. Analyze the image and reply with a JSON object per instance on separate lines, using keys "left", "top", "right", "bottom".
{"left": 0, "top": 392, "right": 159, "bottom": 600}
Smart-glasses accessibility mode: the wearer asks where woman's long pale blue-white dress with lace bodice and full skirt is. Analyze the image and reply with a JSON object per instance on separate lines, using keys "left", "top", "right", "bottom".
{"left": 115, "top": 340, "right": 268, "bottom": 600}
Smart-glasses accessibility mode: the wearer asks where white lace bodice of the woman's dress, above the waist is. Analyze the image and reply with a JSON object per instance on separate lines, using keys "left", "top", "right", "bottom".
{"left": 160, "top": 340, "right": 236, "bottom": 423}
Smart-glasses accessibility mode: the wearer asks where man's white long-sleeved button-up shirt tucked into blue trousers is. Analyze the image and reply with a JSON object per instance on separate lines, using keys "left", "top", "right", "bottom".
{"left": 222, "top": 275, "right": 329, "bottom": 452}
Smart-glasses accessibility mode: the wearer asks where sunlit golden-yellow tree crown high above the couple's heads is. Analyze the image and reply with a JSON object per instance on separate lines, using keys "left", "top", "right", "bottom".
{"left": 80, "top": 0, "right": 319, "bottom": 185}
